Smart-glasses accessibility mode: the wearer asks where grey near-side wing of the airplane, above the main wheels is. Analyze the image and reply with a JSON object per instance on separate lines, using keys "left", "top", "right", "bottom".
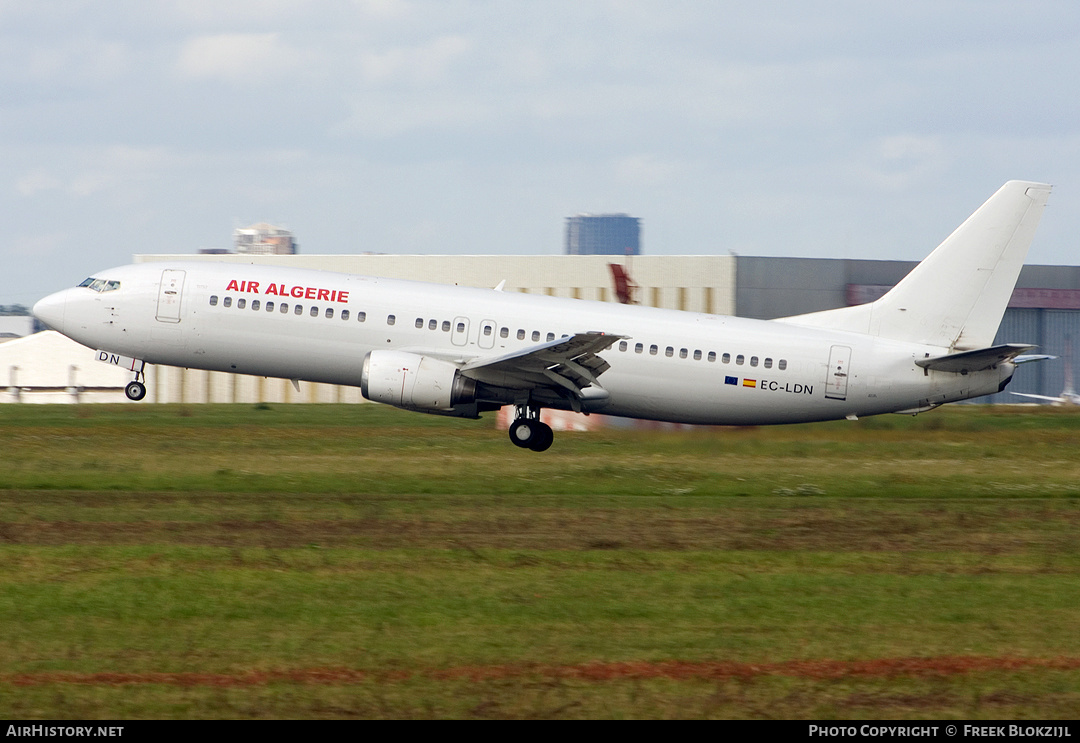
{"left": 461, "top": 330, "right": 626, "bottom": 400}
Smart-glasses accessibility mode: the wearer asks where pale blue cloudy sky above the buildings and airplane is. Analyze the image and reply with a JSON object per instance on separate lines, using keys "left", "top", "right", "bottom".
{"left": 0, "top": 0, "right": 1080, "bottom": 306}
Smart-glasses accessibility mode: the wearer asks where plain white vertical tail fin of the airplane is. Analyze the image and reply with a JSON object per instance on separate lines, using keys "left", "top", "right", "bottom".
{"left": 781, "top": 180, "right": 1050, "bottom": 351}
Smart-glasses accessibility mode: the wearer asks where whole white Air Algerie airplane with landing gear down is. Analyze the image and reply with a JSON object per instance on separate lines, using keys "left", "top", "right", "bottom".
{"left": 33, "top": 180, "right": 1050, "bottom": 451}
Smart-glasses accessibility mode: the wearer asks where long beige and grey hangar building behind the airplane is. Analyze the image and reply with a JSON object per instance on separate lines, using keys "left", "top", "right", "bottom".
{"left": 0, "top": 254, "right": 1080, "bottom": 403}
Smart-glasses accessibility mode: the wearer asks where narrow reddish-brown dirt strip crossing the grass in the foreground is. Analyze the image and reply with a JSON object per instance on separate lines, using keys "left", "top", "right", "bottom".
{"left": 8, "top": 656, "right": 1080, "bottom": 687}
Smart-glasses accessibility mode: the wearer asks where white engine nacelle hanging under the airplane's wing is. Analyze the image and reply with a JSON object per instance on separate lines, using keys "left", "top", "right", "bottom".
{"left": 360, "top": 351, "right": 477, "bottom": 418}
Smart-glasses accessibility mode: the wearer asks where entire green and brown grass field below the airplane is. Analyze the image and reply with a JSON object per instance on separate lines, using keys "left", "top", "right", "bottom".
{"left": 0, "top": 405, "right": 1080, "bottom": 719}
